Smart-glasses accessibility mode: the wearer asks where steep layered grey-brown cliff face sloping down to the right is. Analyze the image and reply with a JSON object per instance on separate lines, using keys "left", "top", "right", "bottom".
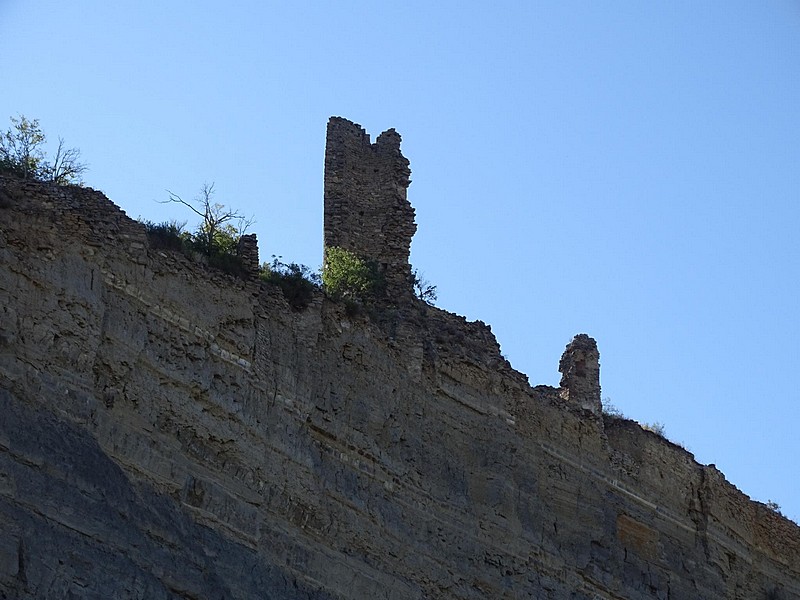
{"left": 0, "top": 149, "right": 800, "bottom": 599}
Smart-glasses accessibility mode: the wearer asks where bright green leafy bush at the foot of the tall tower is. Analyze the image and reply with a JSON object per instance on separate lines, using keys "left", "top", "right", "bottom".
{"left": 322, "top": 246, "right": 386, "bottom": 301}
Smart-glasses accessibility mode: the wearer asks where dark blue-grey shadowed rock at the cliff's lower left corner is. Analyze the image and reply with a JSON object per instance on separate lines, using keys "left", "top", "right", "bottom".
{"left": 0, "top": 389, "right": 331, "bottom": 600}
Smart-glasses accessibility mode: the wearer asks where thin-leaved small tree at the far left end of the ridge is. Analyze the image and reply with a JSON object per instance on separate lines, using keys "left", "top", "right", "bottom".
{"left": 0, "top": 115, "right": 87, "bottom": 185}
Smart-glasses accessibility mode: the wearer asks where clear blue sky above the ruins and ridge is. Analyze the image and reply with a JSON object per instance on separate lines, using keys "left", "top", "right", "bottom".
{"left": 0, "top": 0, "right": 800, "bottom": 520}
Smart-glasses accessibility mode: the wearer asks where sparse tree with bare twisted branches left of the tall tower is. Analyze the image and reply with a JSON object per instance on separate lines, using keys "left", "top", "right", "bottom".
{"left": 162, "top": 183, "right": 255, "bottom": 257}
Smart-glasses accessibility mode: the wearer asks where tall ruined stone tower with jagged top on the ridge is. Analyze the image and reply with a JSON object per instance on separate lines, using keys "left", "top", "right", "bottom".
{"left": 325, "top": 117, "right": 417, "bottom": 298}
